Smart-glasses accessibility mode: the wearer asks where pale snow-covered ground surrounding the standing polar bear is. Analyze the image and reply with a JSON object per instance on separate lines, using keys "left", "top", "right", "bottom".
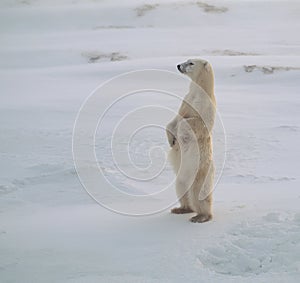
{"left": 0, "top": 0, "right": 300, "bottom": 283}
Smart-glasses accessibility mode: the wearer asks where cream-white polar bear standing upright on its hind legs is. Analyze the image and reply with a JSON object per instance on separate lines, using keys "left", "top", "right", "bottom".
{"left": 166, "top": 59, "right": 216, "bottom": 223}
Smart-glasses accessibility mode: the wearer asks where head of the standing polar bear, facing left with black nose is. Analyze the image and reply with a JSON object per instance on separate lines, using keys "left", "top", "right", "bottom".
{"left": 177, "top": 59, "right": 214, "bottom": 95}
